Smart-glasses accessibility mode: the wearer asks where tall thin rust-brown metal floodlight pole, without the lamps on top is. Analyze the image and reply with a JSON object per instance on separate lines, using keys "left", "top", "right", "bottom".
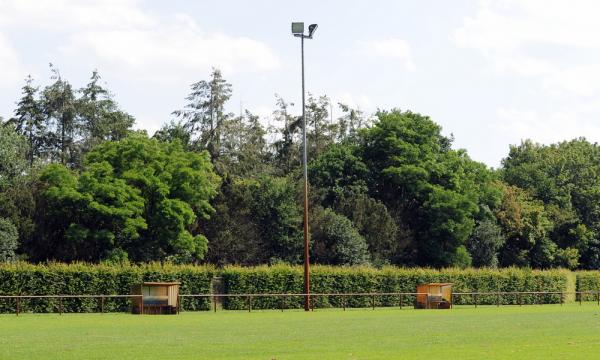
{"left": 300, "top": 35, "right": 310, "bottom": 311}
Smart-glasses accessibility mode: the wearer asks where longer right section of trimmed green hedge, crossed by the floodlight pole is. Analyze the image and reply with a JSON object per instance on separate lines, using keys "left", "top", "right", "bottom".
{"left": 221, "top": 265, "right": 574, "bottom": 310}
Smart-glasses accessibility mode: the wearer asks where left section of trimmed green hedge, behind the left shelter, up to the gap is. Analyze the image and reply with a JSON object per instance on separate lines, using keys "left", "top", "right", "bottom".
{"left": 0, "top": 263, "right": 215, "bottom": 313}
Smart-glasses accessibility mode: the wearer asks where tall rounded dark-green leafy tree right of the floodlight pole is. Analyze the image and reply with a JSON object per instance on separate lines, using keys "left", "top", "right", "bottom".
{"left": 360, "top": 110, "right": 492, "bottom": 266}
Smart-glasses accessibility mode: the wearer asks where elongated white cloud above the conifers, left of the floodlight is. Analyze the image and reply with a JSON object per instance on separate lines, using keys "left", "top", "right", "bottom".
{"left": 60, "top": 20, "right": 279, "bottom": 79}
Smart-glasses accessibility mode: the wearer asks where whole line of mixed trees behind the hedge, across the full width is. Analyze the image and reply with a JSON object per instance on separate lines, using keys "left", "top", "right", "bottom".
{"left": 0, "top": 67, "right": 600, "bottom": 269}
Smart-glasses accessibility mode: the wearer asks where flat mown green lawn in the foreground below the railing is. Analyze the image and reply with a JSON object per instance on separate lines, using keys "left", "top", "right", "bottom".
{"left": 0, "top": 303, "right": 600, "bottom": 360}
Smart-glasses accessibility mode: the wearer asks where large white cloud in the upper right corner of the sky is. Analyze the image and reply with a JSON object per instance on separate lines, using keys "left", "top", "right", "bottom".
{"left": 452, "top": 0, "right": 600, "bottom": 94}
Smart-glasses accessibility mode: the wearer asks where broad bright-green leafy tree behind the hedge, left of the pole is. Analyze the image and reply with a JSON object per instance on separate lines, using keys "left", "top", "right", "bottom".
{"left": 30, "top": 134, "right": 219, "bottom": 262}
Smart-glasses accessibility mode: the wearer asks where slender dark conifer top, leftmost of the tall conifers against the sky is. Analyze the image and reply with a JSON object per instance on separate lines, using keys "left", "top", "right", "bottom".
{"left": 8, "top": 76, "right": 46, "bottom": 165}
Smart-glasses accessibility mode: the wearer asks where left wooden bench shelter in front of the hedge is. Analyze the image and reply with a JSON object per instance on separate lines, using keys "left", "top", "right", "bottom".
{"left": 131, "top": 282, "right": 181, "bottom": 314}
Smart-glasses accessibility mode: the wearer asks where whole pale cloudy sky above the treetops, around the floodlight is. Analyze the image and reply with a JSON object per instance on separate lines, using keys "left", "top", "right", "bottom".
{"left": 0, "top": 0, "right": 600, "bottom": 167}
